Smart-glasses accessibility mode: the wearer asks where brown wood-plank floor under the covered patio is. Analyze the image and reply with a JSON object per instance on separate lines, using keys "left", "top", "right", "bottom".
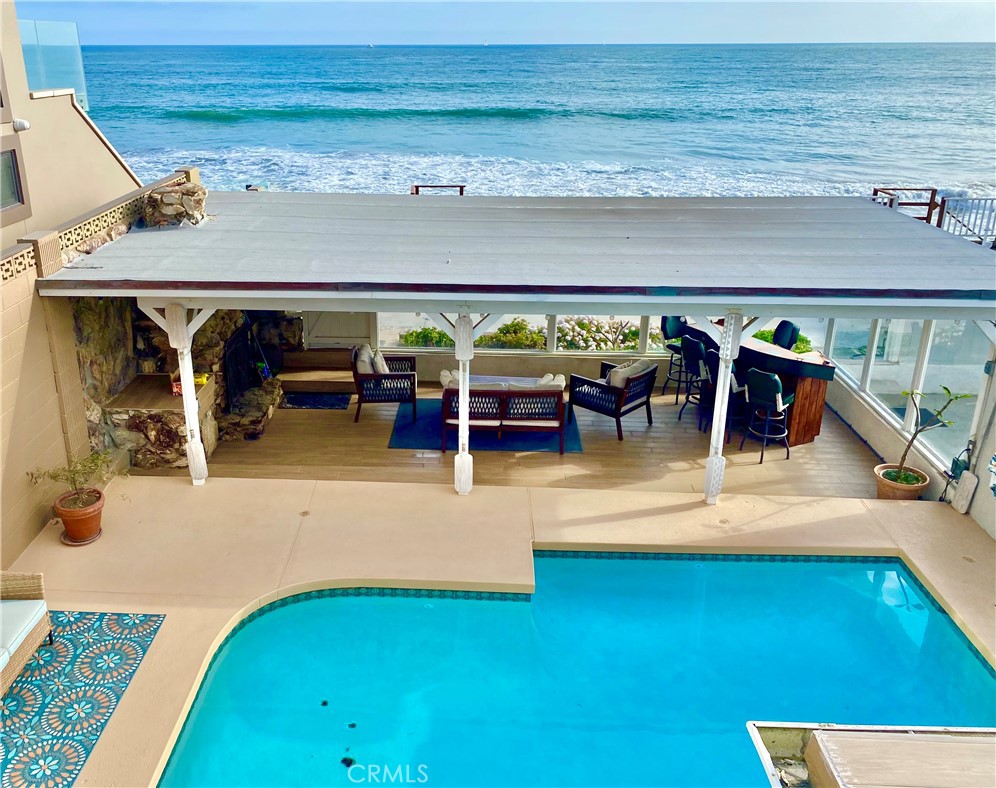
{"left": 136, "top": 387, "right": 877, "bottom": 498}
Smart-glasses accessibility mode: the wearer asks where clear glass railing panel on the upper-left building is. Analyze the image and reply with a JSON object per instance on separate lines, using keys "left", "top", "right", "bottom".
{"left": 18, "top": 19, "right": 89, "bottom": 109}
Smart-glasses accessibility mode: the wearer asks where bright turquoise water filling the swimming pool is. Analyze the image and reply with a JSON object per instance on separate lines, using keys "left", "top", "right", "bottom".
{"left": 161, "top": 554, "right": 996, "bottom": 786}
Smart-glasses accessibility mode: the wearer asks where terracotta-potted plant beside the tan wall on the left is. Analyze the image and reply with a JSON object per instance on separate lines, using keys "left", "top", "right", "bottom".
{"left": 28, "top": 451, "right": 115, "bottom": 547}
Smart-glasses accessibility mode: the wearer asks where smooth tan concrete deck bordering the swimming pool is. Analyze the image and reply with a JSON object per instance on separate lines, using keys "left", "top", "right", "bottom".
{"left": 12, "top": 477, "right": 996, "bottom": 786}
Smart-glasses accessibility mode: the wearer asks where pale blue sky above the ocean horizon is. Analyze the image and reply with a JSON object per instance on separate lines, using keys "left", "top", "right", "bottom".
{"left": 17, "top": 0, "right": 996, "bottom": 45}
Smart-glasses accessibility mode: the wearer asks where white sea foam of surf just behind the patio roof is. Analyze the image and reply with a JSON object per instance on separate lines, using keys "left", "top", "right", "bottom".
{"left": 126, "top": 148, "right": 993, "bottom": 197}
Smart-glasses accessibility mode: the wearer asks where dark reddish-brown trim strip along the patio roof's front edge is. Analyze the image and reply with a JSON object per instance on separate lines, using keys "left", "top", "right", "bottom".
{"left": 38, "top": 276, "right": 996, "bottom": 302}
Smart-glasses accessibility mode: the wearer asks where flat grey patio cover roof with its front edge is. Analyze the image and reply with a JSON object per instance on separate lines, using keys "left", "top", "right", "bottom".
{"left": 38, "top": 192, "right": 996, "bottom": 320}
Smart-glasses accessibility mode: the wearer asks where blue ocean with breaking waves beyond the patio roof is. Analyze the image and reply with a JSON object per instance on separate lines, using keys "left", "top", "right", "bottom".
{"left": 83, "top": 44, "right": 996, "bottom": 196}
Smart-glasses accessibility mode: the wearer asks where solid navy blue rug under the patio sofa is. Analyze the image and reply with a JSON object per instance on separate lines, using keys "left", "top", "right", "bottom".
{"left": 387, "top": 399, "right": 582, "bottom": 454}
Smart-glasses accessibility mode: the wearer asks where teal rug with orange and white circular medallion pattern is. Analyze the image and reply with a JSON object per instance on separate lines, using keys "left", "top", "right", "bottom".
{"left": 0, "top": 610, "right": 165, "bottom": 788}
